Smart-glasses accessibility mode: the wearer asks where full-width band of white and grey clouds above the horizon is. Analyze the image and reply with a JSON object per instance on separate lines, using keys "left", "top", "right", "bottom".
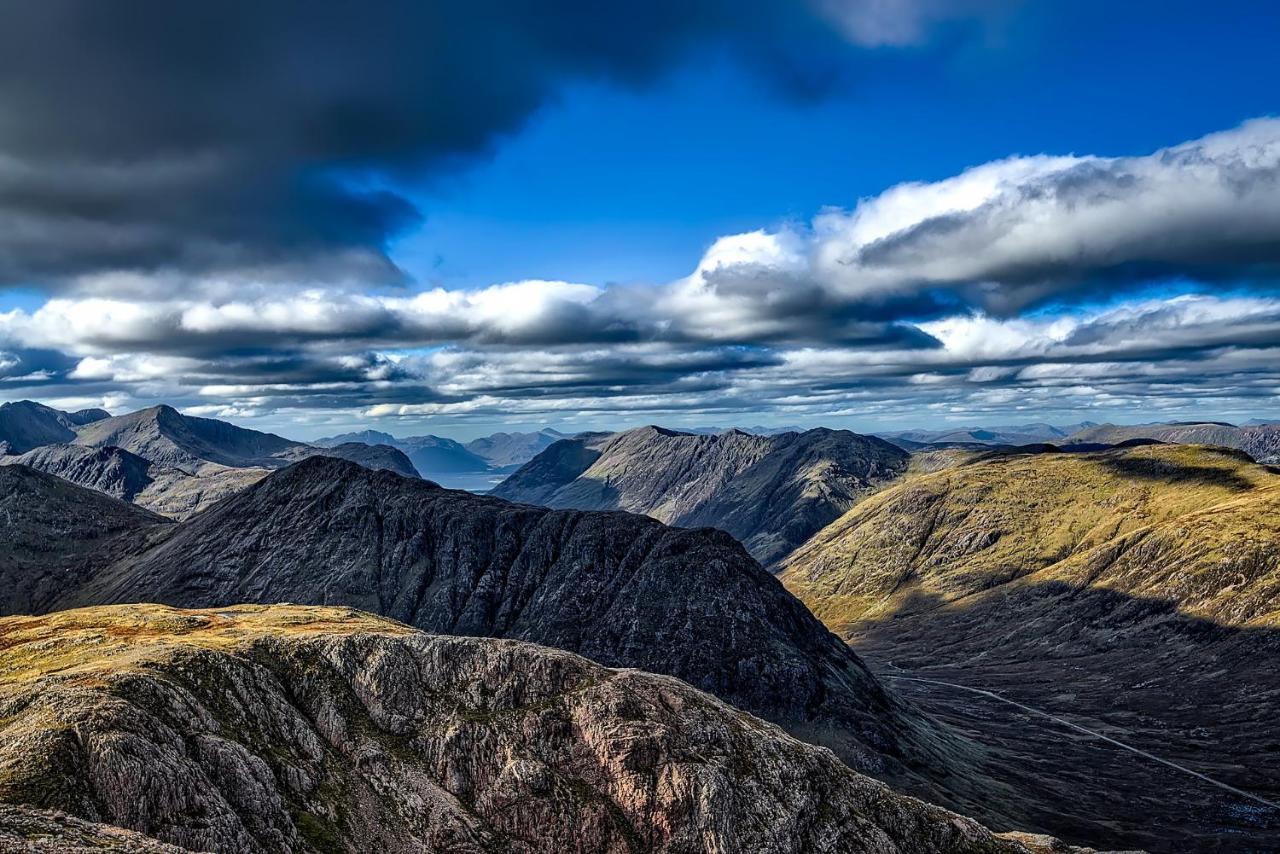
{"left": 0, "top": 113, "right": 1280, "bottom": 429}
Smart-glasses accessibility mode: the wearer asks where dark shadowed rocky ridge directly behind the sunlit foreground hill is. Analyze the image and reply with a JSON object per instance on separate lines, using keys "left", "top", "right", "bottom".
{"left": 59, "top": 457, "right": 954, "bottom": 809}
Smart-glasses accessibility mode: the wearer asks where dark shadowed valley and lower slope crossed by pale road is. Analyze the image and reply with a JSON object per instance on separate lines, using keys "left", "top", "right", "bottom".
{"left": 849, "top": 581, "right": 1280, "bottom": 851}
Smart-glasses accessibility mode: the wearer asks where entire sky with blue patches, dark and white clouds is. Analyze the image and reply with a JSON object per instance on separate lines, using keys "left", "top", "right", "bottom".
{"left": 0, "top": 0, "right": 1280, "bottom": 438}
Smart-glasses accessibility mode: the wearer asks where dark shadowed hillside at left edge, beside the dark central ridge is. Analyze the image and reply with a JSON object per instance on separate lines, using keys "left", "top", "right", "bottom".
{"left": 0, "top": 465, "right": 163, "bottom": 615}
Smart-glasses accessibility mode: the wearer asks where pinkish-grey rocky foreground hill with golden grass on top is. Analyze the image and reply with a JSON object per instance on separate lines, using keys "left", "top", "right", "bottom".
{"left": 0, "top": 606, "right": 1085, "bottom": 854}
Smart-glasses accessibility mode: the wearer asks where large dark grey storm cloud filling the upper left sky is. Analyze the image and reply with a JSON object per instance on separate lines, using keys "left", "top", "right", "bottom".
{"left": 0, "top": 0, "right": 860, "bottom": 287}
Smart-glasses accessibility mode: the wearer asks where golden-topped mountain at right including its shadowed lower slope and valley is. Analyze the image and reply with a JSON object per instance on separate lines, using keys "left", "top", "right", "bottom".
{"left": 781, "top": 445, "right": 1280, "bottom": 851}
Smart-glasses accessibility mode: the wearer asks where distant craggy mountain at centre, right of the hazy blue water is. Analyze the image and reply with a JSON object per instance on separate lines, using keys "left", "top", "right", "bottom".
{"left": 493, "top": 426, "right": 908, "bottom": 563}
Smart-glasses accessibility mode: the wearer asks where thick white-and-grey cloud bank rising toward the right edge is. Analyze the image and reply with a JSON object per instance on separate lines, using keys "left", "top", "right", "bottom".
{"left": 695, "top": 119, "right": 1280, "bottom": 319}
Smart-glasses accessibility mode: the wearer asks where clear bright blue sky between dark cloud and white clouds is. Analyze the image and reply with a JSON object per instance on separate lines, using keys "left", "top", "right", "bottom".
{"left": 396, "top": 1, "right": 1280, "bottom": 287}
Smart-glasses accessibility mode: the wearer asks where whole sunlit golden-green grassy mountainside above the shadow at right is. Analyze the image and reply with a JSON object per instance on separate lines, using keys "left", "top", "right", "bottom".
{"left": 782, "top": 444, "right": 1280, "bottom": 632}
